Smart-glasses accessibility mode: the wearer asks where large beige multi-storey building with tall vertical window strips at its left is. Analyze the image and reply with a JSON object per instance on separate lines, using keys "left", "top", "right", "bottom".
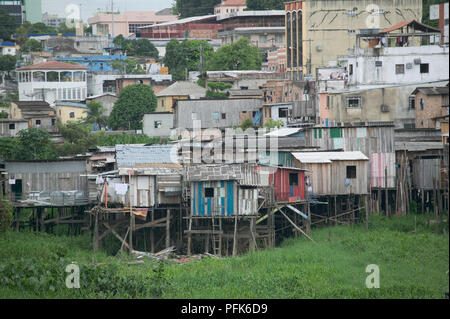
{"left": 285, "top": 0, "right": 422, "bottom": 80}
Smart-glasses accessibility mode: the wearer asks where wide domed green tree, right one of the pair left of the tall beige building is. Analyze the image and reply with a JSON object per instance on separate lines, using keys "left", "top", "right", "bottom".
{"left": 206, "top": 37, "right": 262, "bottom": 71}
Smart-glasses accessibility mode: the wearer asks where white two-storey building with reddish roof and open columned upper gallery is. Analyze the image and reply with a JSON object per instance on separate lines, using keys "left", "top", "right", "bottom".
{"left": 16, "top": 61, "right": 87, "bottom": 106}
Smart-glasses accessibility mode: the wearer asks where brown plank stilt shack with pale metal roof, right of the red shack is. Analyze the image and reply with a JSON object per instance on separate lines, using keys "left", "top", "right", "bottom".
{"left": 292, "top": 151, "right": 369, "bottom": 196}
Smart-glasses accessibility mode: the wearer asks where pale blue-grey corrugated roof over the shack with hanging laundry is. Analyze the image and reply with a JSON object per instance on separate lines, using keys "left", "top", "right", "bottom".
{"left": 116, "top": 145, "right": 179, "bottom": 168}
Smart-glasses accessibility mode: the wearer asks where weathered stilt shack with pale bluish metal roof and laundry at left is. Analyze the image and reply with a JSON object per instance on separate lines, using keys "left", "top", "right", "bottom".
{"left": 105, "top": 145, "right": 182, "bottom": 207}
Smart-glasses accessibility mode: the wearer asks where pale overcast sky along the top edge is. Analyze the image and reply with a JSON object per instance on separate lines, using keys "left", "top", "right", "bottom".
{"left": 42, "top": 0, "right": 174, "bottom": 21}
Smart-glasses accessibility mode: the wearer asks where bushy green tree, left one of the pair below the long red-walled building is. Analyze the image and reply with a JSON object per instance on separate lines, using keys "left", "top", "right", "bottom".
{"left": 163, "top": 39, "right": 214, "bottom": 81}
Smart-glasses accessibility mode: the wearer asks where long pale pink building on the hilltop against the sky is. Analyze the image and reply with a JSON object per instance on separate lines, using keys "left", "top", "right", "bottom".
{"left": 88, "top": 11, "right": 178, "bottom": 37}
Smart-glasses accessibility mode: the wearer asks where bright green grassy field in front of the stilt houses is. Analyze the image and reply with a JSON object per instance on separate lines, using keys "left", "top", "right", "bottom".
{"left": 0, "top": 216, "right": 449, "bottom": 298}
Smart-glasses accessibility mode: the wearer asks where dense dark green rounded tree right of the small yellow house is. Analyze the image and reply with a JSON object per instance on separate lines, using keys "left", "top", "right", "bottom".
{"left": 108, "top": 84, "right": 156, "bottom": 130}
